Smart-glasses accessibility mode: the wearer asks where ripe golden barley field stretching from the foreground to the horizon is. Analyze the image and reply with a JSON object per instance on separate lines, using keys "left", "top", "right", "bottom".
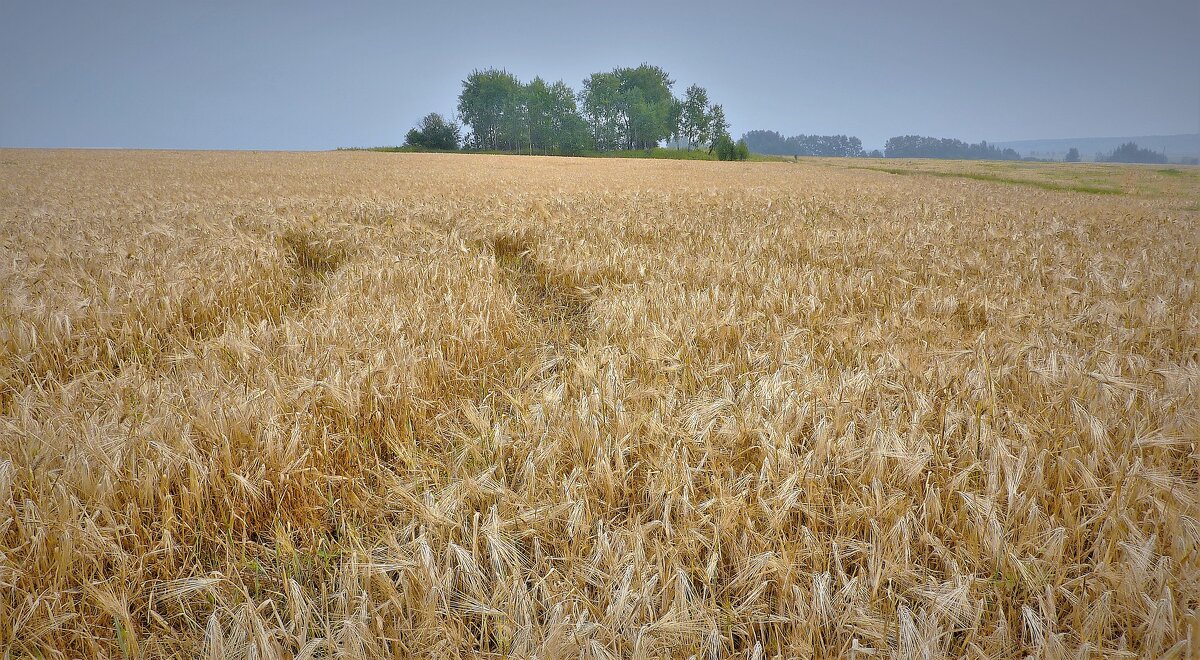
{"left": 0, "top": 150, "right": 1200, "bottom": 659}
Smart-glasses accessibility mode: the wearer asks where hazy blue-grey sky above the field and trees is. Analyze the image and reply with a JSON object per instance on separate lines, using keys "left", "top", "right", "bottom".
{"left": 0, "top": 0, "right": 1200, "bottom": 149}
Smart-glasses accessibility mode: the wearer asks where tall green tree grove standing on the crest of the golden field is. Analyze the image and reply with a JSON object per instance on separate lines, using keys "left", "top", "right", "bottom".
{"left": 407, "top": 64, "right": 737, "bottom": 155}
